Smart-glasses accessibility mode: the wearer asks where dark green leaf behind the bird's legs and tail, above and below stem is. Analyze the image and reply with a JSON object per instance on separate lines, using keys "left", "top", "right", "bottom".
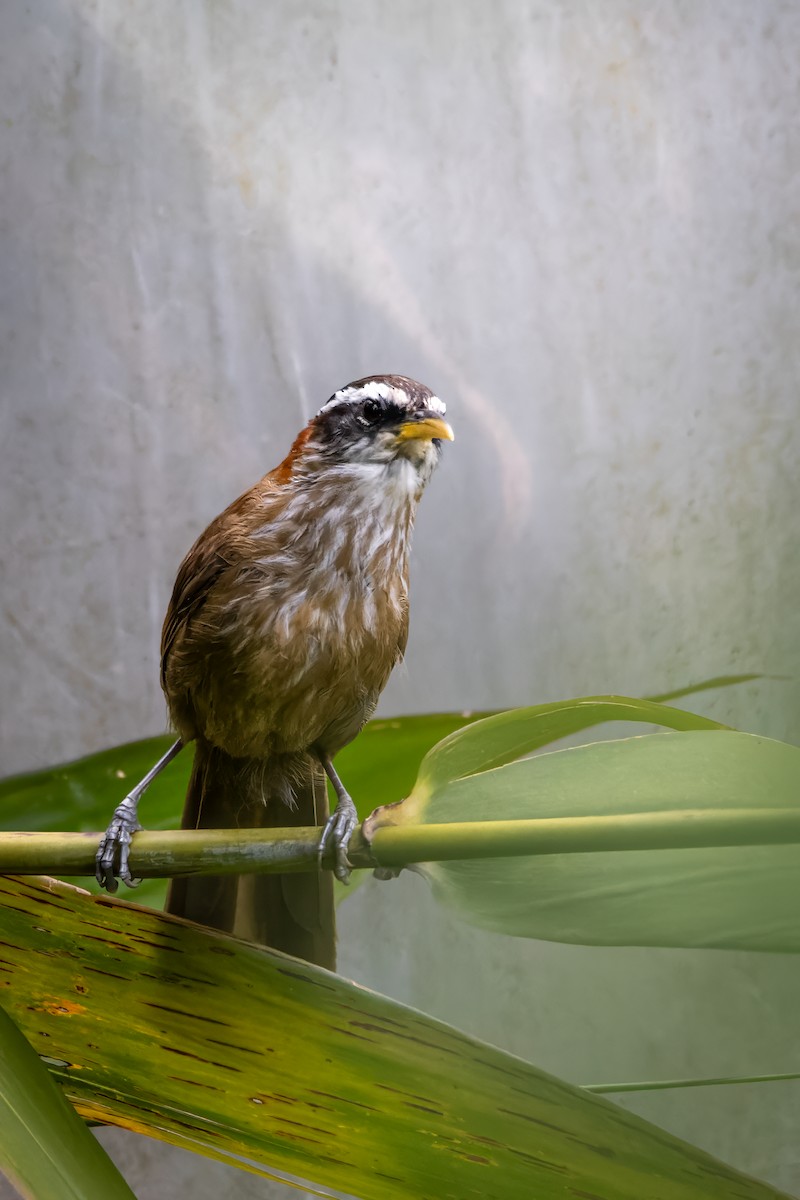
{"left": 0, "top": 713, "right": 484, "bottom": 908}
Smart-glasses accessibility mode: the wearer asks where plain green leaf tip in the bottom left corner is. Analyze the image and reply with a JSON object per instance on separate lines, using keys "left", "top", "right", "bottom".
{"left": 0, "top": 1003, "right": 134, "bottom": 1200}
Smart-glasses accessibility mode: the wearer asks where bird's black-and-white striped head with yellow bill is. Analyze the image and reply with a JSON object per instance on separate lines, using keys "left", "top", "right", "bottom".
{"left": 299, "top": 376, "right": 453, "bottom": 485}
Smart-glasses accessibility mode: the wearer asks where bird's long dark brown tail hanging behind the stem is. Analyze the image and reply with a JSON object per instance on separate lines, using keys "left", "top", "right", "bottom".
{"left": 167, "top": 740, "right": 336, "bottom": 971}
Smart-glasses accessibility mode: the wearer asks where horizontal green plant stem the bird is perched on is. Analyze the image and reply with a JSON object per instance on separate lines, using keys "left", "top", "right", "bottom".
{"left": 0, "top": 809, "right": 800, "bottom": 878}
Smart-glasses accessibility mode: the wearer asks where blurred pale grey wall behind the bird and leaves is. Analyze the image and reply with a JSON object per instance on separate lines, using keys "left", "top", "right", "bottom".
{"left": 0, "top": 0, "right": 800, "bottom": 1200}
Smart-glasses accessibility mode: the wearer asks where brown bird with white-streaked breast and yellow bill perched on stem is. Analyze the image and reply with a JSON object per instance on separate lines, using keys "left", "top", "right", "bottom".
{"left": 96, "top": 374, "right": 453, "bottom": 970}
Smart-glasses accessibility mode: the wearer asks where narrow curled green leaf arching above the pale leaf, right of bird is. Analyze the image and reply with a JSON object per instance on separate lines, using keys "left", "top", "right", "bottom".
{"left": 413, "top": 696, "right": 724, "bottom": 806}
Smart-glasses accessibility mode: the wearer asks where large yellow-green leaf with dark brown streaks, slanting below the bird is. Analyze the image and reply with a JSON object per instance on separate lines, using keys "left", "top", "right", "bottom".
{"left": 0, "top": 878, "right": 777, "bottom": 1200}
